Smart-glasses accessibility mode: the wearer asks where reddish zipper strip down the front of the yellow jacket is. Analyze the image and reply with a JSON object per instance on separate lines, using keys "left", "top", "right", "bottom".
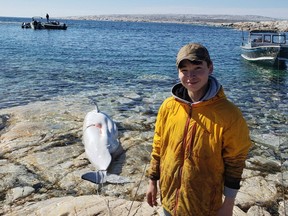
{"left": 174, "top": 105, "right": 192, "bottom": 216}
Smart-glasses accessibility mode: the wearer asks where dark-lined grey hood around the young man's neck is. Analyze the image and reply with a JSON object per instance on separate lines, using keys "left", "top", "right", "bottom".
{"left": 172, "top": 75, "right": 221, "bottom": 104}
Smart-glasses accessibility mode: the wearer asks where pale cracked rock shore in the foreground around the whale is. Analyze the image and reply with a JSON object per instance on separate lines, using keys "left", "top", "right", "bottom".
{"left": 0, "top": 92, "right": 288, "bottom": 216}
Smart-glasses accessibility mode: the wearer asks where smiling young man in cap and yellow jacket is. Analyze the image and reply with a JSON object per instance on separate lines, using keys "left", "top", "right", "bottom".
{"left": 146, "top": 43, "right": 251, "bottom": 216}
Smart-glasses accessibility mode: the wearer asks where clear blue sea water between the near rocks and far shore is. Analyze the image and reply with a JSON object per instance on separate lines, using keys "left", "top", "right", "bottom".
{"left": 0, "top": 17, "right": 288, "bottom": 138}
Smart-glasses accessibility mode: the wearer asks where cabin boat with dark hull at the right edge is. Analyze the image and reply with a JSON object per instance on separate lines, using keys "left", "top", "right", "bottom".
{"left": 241, "top": 30, "right": 288, "bottom": 68}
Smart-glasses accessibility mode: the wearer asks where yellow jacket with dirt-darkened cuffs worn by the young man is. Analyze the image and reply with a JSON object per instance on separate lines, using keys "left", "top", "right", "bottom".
{"left": 148, "top": 84, "right": 251, "bottom": 216}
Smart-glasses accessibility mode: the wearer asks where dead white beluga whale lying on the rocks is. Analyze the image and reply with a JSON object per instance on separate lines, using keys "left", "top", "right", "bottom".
{"left": 81, "top": 104, "right": 131, "bottom": 184}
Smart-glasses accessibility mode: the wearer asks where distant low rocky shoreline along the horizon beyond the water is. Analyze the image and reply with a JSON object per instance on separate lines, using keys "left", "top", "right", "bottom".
{"left": 65, "top": 14, "right": 288, "bottom": 32}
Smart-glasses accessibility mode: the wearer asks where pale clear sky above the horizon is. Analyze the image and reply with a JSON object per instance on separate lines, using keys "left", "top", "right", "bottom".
{"left": 0, "top": 0, "right": 288, "bottom": 20}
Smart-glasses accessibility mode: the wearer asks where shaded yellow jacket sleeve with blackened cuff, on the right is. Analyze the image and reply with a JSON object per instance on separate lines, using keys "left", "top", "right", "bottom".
{"left": 223, "top": 114, "right": 251, "bottom": 189}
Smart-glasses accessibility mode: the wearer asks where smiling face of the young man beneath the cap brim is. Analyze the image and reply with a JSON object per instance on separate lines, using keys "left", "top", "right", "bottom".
{"left": 178, "top": 60, "right": 213, "bottom": 94}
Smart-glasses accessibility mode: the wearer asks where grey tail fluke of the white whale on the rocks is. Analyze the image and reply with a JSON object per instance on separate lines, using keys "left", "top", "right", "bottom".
{"left": 81, "top": 170, "right": 133, "bottom": 184}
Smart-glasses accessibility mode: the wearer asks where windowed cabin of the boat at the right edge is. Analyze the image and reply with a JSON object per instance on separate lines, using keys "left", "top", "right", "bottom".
{"left": 248, "top": 30, "right": 286, "bottom": 47}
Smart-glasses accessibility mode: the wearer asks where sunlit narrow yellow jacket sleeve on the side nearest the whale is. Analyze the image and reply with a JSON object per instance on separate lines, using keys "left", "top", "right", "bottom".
{"left": 147, "top": 104, "right": 164, "bottom": 180}
